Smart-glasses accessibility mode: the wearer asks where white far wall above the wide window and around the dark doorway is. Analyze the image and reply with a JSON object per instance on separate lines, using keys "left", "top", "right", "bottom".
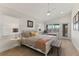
{"left": 45, "top": 13, "right": 71, "bottom": 39}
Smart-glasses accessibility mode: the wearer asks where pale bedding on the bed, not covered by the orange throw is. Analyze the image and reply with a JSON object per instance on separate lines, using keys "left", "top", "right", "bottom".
{"left": 22, "top": 35, "right": 55, "bottom": 46}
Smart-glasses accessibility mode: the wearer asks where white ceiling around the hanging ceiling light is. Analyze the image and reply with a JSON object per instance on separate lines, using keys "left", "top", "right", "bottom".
{"left": 0, "top": 3, "right": 73, "bottom": 21}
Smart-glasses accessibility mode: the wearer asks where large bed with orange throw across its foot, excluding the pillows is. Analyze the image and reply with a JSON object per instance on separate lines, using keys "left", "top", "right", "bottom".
{"left": 22, "top": 35, "right": 56, "bottom": 55}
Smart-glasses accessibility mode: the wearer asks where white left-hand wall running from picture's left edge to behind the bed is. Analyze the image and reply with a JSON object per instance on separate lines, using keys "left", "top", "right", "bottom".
{"left": 0, "top": 13, "right": 43, "bottom": 52}
